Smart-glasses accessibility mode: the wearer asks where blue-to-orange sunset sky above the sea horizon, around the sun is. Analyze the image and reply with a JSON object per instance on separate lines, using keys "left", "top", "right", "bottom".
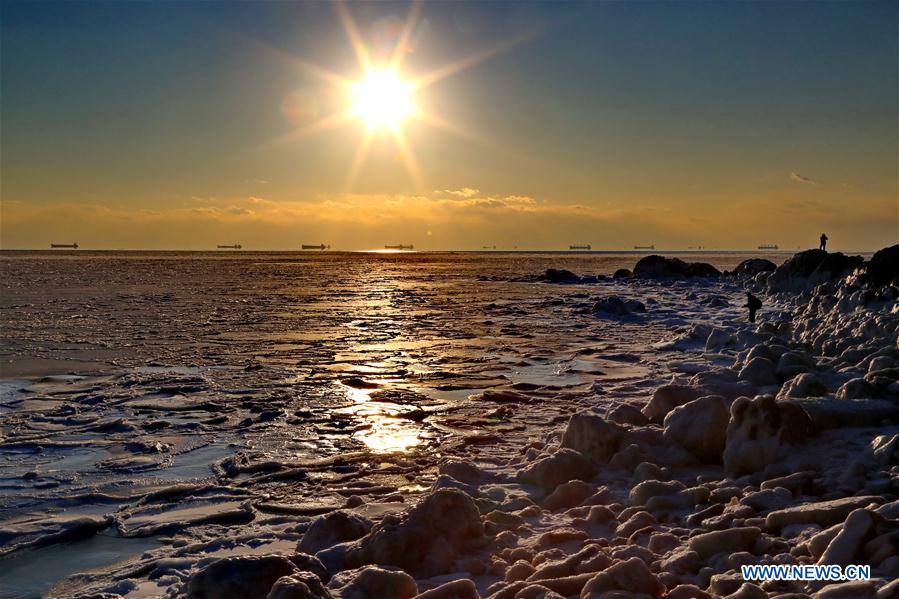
{"left": 0, "top": 1, "right": 899, "bottom": 251}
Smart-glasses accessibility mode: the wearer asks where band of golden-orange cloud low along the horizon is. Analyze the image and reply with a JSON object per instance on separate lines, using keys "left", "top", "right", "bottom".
{"left": 0, "top": 187, "right": 897, "bottom": 249}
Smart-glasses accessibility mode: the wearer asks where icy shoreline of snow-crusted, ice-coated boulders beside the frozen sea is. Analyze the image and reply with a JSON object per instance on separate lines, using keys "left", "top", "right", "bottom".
{"left": 2, "top": 246, "right": 899, "bottom": 599}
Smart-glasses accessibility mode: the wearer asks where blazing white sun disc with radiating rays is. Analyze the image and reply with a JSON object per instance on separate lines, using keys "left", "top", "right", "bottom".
{"left": 350, "top": 69, "right": 415, "bottom": 130}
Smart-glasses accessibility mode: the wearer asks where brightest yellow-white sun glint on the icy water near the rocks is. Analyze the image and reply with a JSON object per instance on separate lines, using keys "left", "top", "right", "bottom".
{"left": 338, "top": 385, "right": 422, "bottom": 453}
